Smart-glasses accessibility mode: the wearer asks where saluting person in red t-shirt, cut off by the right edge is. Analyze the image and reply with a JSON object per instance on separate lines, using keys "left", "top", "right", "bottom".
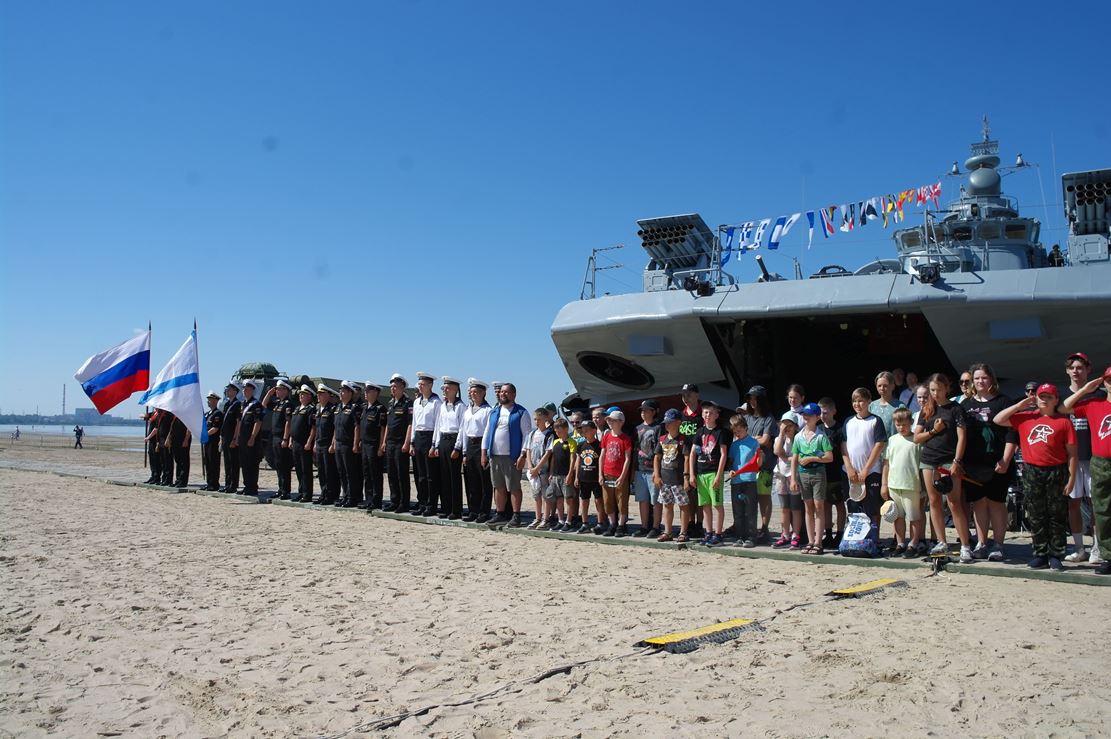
{"left": 1060, "top": 367, "right": 1111, "bottom": 575}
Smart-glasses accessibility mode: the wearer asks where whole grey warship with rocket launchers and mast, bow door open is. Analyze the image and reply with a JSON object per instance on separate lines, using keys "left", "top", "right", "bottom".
{"left": 551, "top": 120, "right": 1111, "bottom": 413}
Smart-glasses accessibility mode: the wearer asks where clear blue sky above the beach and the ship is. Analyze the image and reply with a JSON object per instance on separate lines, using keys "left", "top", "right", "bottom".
{"left": 0, "top": 0, "right": 1111, "bottom": 413}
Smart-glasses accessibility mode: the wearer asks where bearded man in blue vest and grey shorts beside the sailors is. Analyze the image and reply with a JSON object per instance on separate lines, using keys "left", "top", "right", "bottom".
{"left": 482, "top": 382, "right": 532, "bottom": 529}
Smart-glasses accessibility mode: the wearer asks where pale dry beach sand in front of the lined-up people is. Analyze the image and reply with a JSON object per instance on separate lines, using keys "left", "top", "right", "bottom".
{"left": 0, "top": 440, "right": 1111, "bottom": 737}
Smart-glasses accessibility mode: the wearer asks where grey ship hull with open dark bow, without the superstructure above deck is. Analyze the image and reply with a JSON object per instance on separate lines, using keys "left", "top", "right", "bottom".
{"left": 551, "top": 262, "right": 1111, "bottom": 412}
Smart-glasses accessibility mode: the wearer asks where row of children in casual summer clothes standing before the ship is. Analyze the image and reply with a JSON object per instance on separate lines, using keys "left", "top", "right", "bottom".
{"left": 513, "top": 355, "right": 1111, "bottom": 568}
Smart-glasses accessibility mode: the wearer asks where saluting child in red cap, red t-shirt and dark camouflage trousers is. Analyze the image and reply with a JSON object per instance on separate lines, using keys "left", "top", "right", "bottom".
{"left": 995, "top": 382, "right": 1077, "bottom": 570}
